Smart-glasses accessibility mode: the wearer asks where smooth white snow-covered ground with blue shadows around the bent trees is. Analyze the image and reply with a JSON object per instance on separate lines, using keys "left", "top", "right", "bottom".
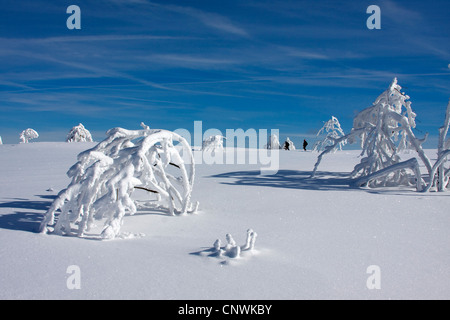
{"left": 0, "top": 142, "right": 450, "bottom": 300}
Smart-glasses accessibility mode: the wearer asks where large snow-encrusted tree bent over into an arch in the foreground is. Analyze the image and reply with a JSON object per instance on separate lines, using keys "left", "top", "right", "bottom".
{"left": 40, "top": 127, "right": 198, "bottom": 239}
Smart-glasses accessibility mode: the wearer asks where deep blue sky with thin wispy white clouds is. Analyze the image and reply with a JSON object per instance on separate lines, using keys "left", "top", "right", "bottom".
{"left": 0, "top": 0, "right": 450, "bottom": 147}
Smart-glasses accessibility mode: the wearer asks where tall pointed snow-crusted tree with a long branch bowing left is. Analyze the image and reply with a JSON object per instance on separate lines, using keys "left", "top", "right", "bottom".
{"left": 314, "top": 78, "right": 429, "bottom": 187}
